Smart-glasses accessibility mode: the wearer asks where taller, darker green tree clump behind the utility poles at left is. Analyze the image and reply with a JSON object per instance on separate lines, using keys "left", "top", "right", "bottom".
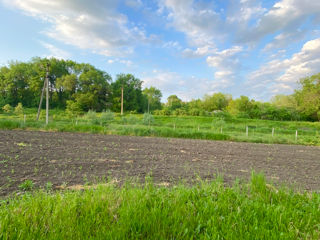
{"left": 0, "top": 58, "right": 162, "bottom": 114}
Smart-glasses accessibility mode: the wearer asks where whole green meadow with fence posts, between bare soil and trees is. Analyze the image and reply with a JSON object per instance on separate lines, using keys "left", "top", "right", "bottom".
{"left": 0, "top": 109, "right": 320, "bottom": 146}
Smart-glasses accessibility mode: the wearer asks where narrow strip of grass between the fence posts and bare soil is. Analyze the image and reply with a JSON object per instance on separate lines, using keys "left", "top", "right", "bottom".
{"left": 0, "top": 119, "right": 320, "bottom": 146}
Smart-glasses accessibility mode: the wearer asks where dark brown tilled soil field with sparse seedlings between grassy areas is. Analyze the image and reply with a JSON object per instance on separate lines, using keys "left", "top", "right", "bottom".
{"left": 0, "top": 130, "right": 320, "bottom": 196}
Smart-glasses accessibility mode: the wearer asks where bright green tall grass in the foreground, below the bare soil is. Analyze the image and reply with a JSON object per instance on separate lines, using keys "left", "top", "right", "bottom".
{"left": 0, "top": 175, "right": 320, "bottom": 239}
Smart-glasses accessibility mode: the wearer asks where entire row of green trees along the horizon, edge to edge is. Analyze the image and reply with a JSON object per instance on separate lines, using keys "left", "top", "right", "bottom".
{"left": 0, "top": 57, "right": 320, "bottom": 121}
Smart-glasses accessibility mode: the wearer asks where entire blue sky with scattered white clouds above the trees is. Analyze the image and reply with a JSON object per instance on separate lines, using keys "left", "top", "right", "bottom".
{"left": 0, "top": 0, "right": 320, "bottom": 101}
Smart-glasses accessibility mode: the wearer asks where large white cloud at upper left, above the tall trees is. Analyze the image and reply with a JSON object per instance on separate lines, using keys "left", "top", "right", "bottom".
{"left": 3, "top": 0, "right": 154, "bottom": 56}
